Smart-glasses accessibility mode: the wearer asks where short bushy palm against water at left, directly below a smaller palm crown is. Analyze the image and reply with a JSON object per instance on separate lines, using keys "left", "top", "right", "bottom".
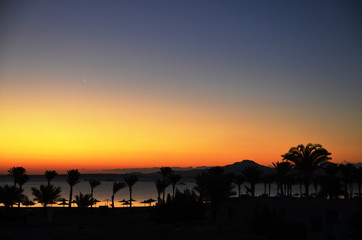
{"left": 31, "top": 185, "right": 61, "bottom": 207}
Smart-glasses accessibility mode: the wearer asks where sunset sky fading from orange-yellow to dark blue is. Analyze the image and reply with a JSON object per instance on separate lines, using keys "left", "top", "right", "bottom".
{"left": 0, "top": 0, "right": 362, "bottom": 173}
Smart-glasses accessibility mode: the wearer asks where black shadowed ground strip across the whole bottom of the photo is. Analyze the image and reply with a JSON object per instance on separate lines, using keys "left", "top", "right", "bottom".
{"left": 0, "top": 198, "right": 362, "bottom": 240}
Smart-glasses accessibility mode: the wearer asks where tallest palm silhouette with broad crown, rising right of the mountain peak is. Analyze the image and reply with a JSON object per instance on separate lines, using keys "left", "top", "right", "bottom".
{"left": 282, "top": 143, "right": 331, "bottom": 197}
